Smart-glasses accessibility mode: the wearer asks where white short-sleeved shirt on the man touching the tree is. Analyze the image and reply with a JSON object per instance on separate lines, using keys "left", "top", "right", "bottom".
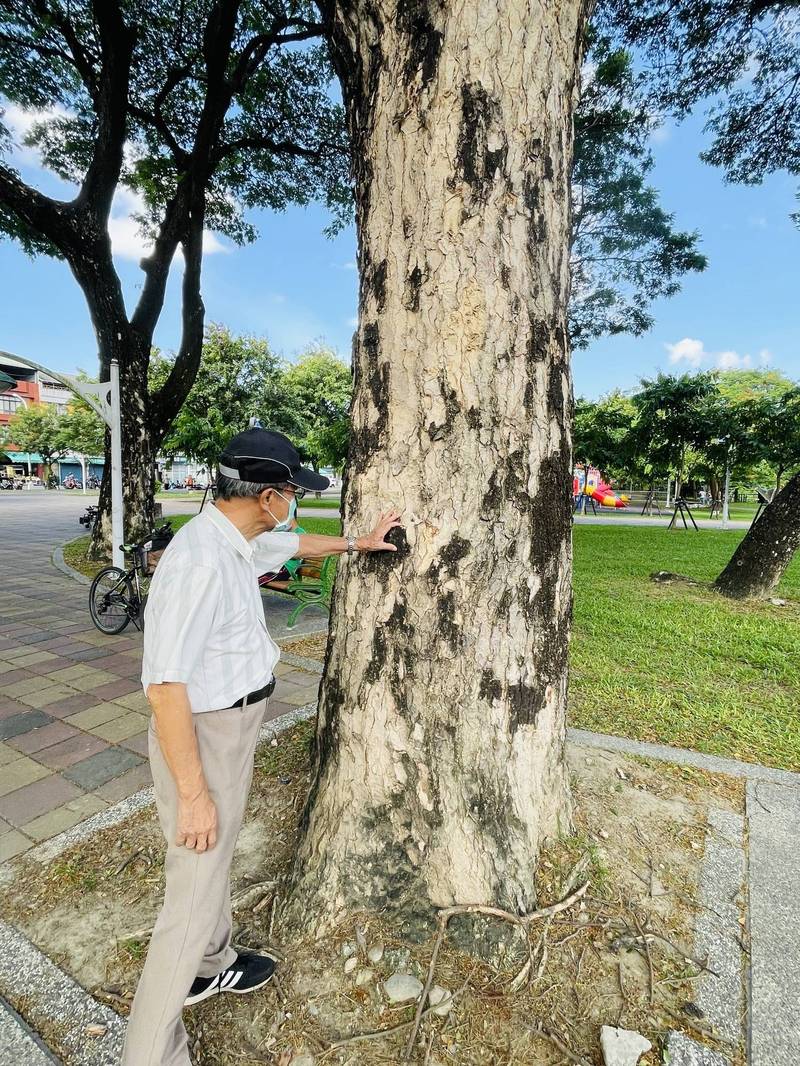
{"left": 142, "top": 505, "right": 300, "bottom": 712}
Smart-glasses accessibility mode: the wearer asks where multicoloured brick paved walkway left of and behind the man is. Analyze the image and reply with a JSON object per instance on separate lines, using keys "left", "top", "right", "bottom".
{"left": 0, "top": 494, "right": 326, "bottom": 861}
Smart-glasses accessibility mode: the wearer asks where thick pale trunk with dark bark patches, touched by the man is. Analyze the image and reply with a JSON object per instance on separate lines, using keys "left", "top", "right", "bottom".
{"left": 288, "top": 0, "right": 585, "bottom": 932}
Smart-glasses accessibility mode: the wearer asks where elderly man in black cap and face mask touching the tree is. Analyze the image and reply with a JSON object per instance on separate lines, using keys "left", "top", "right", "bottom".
{"left": 123, "top": 429, "right": 399, "bottom": 1066}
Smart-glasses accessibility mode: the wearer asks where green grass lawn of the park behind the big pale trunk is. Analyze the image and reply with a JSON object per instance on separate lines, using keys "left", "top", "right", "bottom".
{"left": 64, "top": 515, "right": 800, "bottom": 771}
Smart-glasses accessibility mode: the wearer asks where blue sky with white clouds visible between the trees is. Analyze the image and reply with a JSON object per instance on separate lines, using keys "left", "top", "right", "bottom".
{"left": 0, "top": 102, "right": 800, "bottom": 398}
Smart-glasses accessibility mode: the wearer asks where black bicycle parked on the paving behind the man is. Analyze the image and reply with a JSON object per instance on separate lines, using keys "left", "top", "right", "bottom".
{"left": 89, "top": 524, "right": 175, "bottom": 636}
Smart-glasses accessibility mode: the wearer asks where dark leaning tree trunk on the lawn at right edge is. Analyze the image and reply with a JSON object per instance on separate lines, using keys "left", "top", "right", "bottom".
{"left": 716, "top": 473, "right": 800, "bottom": 599}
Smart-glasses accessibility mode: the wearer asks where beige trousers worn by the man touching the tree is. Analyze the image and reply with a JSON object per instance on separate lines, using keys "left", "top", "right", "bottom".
{"left": 122, "top": 699, "right": 269, "bottom": 1066}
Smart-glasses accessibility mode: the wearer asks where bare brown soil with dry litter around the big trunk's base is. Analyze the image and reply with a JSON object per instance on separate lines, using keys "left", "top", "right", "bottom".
{"left": 0, "top": 720, "right": 743, "bottom": 1066}
